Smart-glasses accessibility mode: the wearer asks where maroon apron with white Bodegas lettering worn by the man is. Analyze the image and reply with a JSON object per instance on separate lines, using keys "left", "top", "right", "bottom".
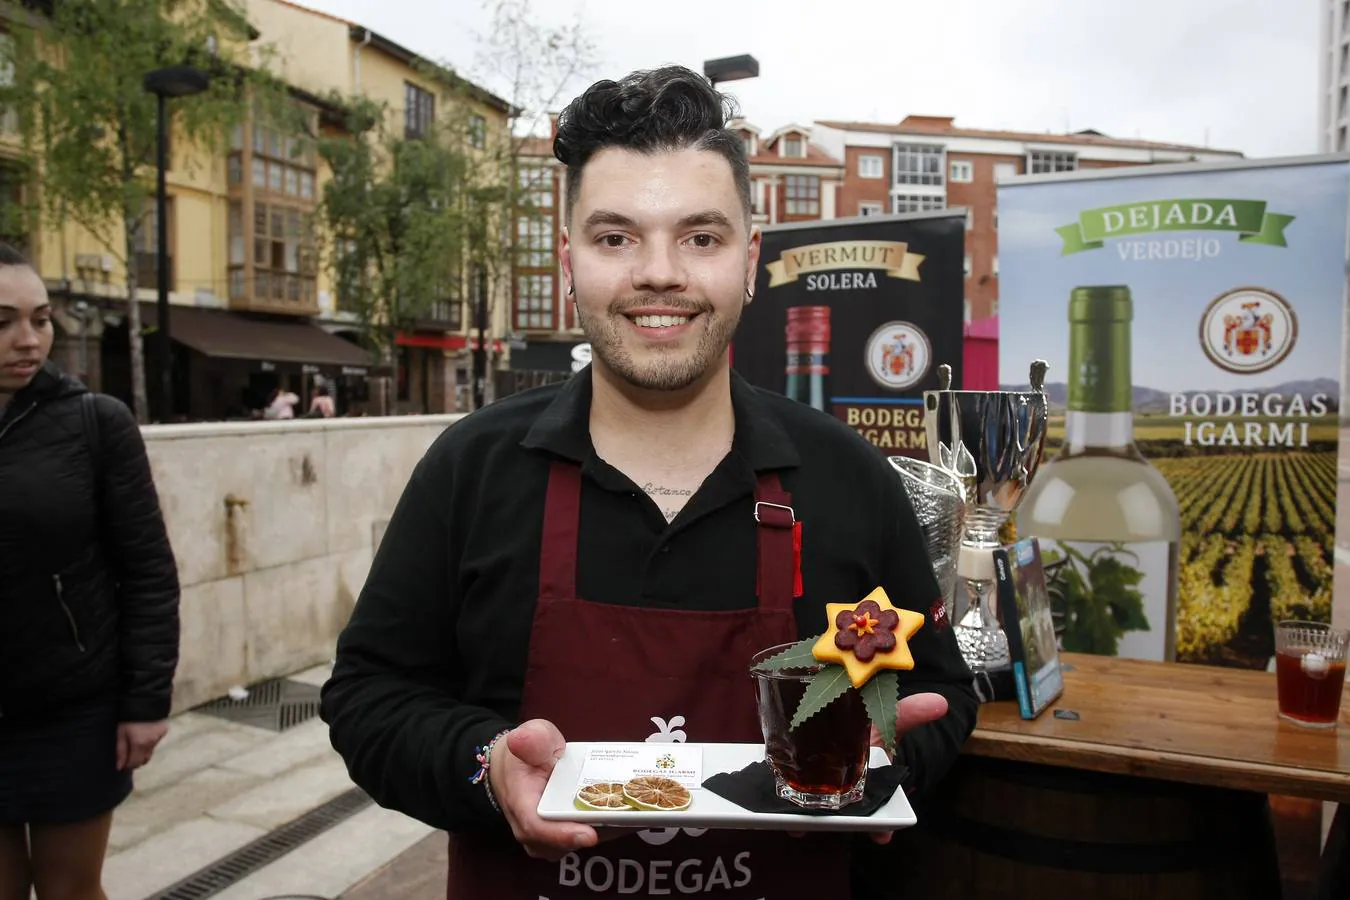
{"left": 446, "top": 461, "right": 851, "bottom": 900}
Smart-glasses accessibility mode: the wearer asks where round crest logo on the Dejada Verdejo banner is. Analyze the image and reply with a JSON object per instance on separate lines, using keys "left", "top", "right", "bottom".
{"left": 1200, "top": 287, "right": 1299, "bottom": 375}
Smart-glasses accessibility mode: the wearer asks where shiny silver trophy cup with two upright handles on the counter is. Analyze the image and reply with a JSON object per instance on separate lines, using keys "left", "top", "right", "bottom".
{"left": 923, "top": 359, "right": 1049, "bottom": 672}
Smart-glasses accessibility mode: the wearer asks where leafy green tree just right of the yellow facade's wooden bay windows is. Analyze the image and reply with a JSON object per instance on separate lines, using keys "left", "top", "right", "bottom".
{"left": 316, "top": 89, "right": 483, "bottom": 410}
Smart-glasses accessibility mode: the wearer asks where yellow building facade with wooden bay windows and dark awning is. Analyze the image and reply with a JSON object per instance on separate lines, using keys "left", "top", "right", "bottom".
{"left": 0, "top": 0, "right": 510, "bottom": 420}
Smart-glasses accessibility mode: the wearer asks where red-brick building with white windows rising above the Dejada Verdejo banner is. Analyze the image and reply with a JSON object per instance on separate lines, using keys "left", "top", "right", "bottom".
{"left": 811, "top": 116, "right": 1241, "bottom": 321}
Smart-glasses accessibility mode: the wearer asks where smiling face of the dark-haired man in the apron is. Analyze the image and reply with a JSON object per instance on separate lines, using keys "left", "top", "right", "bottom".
{"left": 560, "top": 147, "right": 760, "bottom": 391}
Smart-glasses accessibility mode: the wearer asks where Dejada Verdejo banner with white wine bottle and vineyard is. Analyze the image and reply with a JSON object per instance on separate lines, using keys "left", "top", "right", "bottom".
{"left": 998, "top": 157, "right": 1350, "bottom": 669}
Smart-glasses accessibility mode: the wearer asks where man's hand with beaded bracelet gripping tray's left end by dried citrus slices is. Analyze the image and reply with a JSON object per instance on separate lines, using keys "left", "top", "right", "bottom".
{"left": 487, "top": 719, "right": 598, "bottom": 861}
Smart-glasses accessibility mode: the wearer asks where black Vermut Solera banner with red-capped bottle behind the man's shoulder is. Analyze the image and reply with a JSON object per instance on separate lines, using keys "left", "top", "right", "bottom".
{"left": 732, "top": 210, "right": 965, "bottom": 460}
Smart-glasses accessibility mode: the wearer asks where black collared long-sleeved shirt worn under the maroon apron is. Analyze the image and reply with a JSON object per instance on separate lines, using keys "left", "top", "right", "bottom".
{"left": 323, "top": 368, "right": 977, "bottom": 831}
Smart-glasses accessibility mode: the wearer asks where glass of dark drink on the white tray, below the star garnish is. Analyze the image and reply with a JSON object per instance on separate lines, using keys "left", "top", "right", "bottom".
{"left": 751, "top": 644, "right": 871, "bottom": 810}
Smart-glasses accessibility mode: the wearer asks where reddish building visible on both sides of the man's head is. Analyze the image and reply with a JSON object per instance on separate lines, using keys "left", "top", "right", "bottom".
{"left": 502, "top": 117, "right": 845, "bottom": 391}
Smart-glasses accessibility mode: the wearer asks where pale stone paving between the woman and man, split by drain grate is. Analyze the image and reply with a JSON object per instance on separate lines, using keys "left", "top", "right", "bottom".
{"left": 105, "top": 665, "right": 434, "bottom": 900}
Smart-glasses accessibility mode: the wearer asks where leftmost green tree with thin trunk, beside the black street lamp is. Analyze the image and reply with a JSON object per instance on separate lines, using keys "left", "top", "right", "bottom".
{"left": 0, "top": 0, "right": 279, "bottom": 422}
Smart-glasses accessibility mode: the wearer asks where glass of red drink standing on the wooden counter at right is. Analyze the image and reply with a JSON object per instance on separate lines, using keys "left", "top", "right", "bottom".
{"left": 1274, "top": 621, "right": 1350, "bottom": 729}
